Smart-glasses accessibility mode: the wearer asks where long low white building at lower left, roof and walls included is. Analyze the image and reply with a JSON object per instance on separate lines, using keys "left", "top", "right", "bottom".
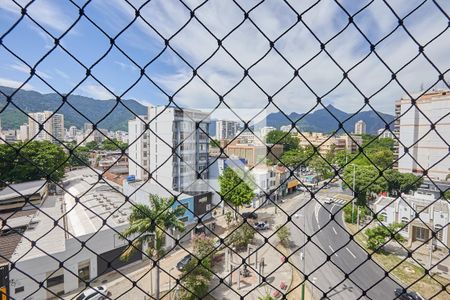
{"left": 9, "top": 169, "right": 135, "bottom": 299}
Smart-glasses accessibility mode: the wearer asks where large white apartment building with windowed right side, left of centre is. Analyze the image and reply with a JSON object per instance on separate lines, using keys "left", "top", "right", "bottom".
{"left": 128, "top": 106, "right": 209, "bottom": 192}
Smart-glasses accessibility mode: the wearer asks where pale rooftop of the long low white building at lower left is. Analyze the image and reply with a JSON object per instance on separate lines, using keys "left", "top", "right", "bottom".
{"left": 12, "top": 168, "right": 131, "bottom": 260}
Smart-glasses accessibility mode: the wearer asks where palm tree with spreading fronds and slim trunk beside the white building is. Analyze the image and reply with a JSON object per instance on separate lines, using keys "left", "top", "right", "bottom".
{"left": 121, "top": 195, "right": 186, "bottom": 299}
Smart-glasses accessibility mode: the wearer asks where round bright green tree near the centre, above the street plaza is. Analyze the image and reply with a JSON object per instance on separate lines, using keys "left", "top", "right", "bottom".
{"left": 219, "top": 167, "right": 255, "bottom": 217}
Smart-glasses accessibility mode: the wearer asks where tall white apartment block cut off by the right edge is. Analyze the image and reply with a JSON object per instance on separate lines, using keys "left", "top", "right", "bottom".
{"left": 394, "top": 90, "right": 450, "bottom": 180}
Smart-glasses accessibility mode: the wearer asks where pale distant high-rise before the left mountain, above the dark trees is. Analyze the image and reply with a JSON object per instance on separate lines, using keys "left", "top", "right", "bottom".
{"left": 28, "top": 111, "right": 65, "bottom": 142}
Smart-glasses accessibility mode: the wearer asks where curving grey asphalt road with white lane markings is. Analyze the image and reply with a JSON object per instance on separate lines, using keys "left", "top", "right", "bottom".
{"left": 284, "top": 193, "right": 400, "bottom": 300}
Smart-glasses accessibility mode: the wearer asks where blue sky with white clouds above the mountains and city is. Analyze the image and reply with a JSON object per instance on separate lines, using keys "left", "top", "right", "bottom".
{"left": 0, "top": 0, "right": 450, "bottom": 118}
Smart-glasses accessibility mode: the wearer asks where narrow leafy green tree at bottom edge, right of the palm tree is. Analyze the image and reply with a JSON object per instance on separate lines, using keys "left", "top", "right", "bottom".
{"left": 180, "top": 234, "right": 214, "bottom": 300}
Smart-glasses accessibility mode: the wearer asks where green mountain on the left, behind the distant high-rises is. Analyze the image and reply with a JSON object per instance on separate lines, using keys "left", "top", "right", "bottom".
{"left": 0, "top": 86, "right": 147, "bottom": 130}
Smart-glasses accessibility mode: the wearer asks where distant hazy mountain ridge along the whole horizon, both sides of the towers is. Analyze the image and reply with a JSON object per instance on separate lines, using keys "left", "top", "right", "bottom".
{"left": 0, "top": 86, "right": 394, "bottom": 136}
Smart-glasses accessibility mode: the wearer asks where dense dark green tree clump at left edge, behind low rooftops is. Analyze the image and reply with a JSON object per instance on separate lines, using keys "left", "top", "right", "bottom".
{"left": 0, "top": 141, "right": 67, "bottom": 183}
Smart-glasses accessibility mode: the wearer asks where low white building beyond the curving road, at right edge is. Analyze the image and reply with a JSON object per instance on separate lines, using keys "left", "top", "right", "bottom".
{"left": 374, "top": 194, "right": 450, "bottom": 248}
